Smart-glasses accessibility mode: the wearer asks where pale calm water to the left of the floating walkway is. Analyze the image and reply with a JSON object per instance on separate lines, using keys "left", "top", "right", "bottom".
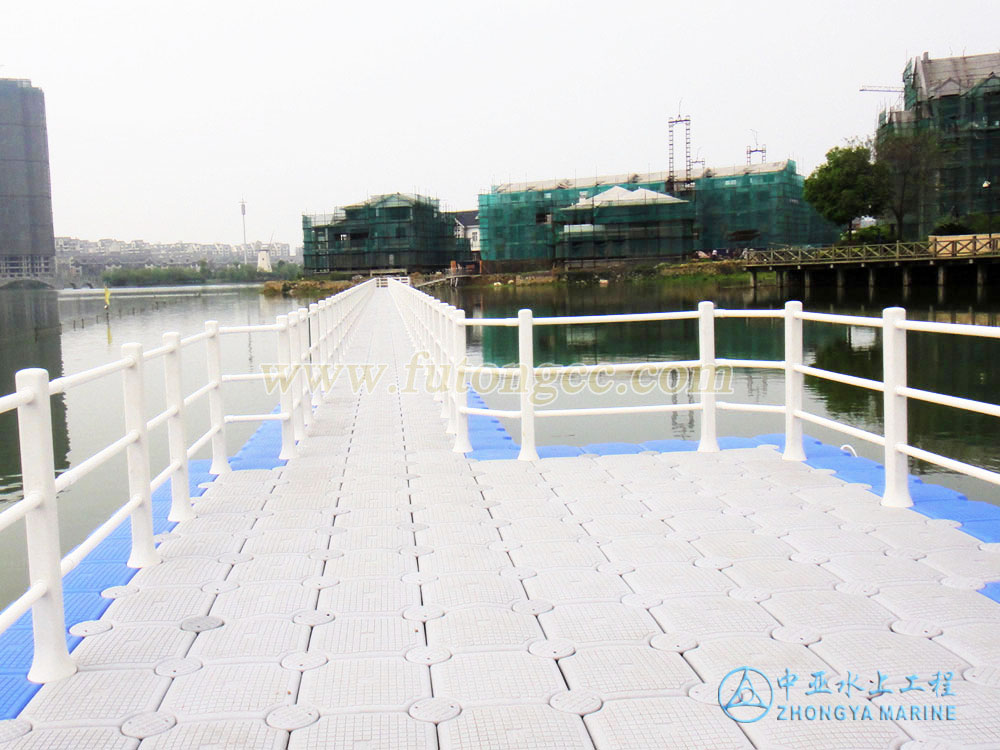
{"left": 0, "top": 286, "right": 310, "bottom": 602}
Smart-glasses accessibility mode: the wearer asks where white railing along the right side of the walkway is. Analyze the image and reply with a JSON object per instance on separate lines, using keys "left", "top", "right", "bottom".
{"left": 390, "top": 284, "right": 1000, "bottom": 507}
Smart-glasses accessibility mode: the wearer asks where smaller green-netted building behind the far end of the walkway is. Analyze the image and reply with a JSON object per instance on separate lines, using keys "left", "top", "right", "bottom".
{"left": 302, "top": 193, "right": 472, "bottom": 273}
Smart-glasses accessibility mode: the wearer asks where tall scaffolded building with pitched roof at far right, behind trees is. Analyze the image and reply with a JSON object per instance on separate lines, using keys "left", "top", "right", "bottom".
{"left": 876, "top": 52, "right": 1000, "bottom": 237}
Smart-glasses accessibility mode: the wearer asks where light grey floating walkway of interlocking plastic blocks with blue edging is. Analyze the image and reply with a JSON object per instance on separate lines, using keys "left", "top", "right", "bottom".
{"left": 0, "top": 282, "right": 1000, "bottom": 750}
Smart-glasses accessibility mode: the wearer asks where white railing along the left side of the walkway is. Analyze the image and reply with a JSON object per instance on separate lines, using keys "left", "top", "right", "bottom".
{"left": 0, "top": 281, "right": 375, "bottom": 682}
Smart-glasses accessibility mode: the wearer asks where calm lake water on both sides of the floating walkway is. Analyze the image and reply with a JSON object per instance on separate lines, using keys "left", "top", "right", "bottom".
{"left": 0, "top": 284, "right": 1000, "bottom": 612}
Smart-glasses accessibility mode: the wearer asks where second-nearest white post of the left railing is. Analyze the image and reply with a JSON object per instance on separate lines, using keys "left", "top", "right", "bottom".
{"left": 122, "top": 344, "right": 160, "bottom": 568}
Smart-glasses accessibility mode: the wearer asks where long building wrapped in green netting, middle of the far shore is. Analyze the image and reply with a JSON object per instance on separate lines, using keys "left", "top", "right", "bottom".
{"left": 479, "top": 160, "right": 839, "bottom": 270}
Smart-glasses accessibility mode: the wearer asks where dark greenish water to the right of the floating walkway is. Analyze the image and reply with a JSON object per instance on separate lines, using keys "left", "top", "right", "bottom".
{"left": 437, "top": 284, "right": 1000, "bottom": 503}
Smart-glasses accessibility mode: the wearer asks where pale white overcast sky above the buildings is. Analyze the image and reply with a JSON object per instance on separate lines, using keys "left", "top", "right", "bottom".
{"left": 0, "top": 0, "right": 1000, "bottom": 250}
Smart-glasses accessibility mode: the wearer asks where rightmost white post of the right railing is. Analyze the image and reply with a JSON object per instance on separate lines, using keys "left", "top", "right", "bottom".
{"left": 882, "top": 307, "right": 913, "bottom": 508}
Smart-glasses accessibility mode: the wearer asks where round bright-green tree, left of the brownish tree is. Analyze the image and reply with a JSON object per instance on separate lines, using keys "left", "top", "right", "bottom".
{"left": 803, "top": 144, "right": 888, "bottom": 236}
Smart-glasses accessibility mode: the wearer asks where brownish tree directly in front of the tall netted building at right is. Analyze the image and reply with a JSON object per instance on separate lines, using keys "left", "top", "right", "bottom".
{"left": 875, "top": 131, "right": 942, "bottom": 239}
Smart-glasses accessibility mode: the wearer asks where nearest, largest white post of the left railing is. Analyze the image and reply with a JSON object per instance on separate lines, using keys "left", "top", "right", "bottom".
{"left": 14, "top": 368, "right": 76, "bottom": 682}
